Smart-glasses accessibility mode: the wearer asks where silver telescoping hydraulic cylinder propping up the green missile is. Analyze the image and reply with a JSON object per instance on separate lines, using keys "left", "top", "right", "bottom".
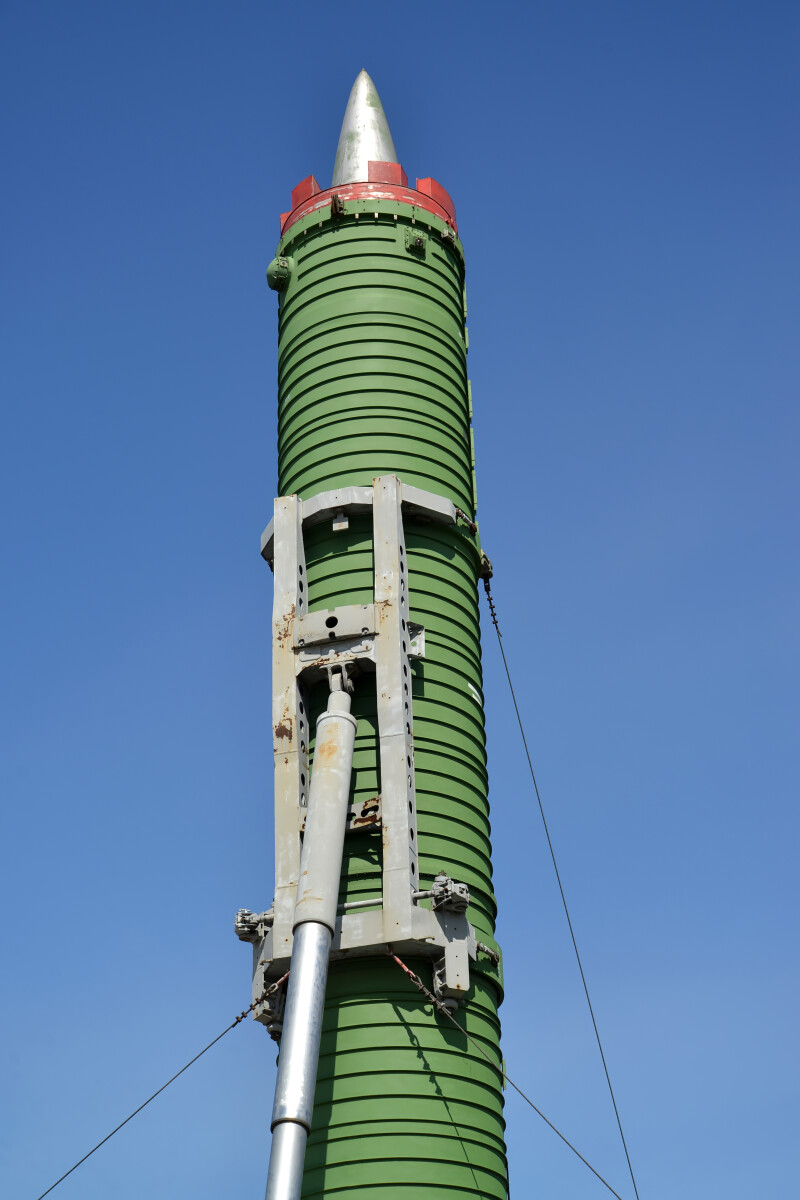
{"left": 266, "top": 674, "right": 356, "bottom": 1200}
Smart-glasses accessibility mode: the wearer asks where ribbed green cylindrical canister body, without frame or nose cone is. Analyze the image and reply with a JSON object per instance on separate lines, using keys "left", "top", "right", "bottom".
{"left": 268, "top": 200, "right": 507, "bottom": 1200}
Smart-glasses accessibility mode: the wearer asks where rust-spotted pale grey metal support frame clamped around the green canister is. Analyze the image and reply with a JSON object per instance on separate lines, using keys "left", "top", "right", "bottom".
{"left": 236, "top": 475, "right": 476, "bottom": 1033}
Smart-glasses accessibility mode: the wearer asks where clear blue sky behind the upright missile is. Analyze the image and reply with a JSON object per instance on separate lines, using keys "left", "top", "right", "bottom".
{"left": 0, "top": 0, "right": 800, "bottom": 1200}
